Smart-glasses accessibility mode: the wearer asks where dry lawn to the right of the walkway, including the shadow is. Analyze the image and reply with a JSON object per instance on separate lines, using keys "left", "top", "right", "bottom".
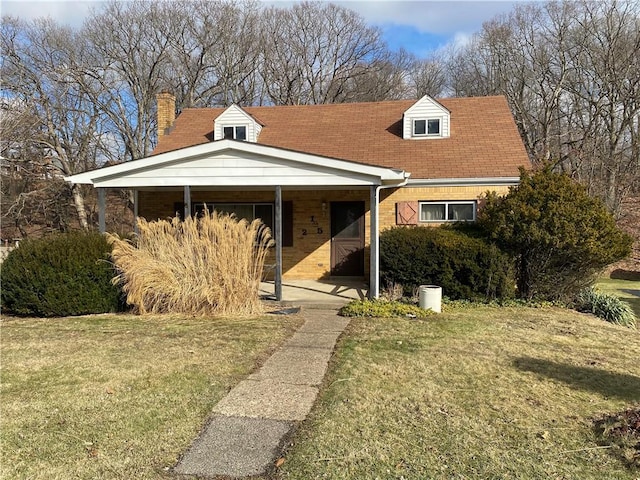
{"left": 275, "top": 307, "right": 640, "bottom": 480}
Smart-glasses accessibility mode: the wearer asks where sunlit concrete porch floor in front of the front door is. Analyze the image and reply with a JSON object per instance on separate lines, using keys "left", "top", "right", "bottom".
{"left": 260, "top": 279, "right": 369, "bottom": 308}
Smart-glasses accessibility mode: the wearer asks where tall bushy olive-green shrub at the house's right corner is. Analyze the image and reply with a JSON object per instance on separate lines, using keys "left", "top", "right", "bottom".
{"left": 479, "top": 167, "right": 632, "bottom": 301}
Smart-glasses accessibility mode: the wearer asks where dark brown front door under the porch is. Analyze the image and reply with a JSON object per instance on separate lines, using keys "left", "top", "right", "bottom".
{"left": 331, "top": 202, "right": 364, "bottom": 277}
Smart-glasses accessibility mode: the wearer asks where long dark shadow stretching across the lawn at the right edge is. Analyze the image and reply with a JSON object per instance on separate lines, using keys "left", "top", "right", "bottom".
{"left": 513, "top": 357, "right": 640, "bottom": 402}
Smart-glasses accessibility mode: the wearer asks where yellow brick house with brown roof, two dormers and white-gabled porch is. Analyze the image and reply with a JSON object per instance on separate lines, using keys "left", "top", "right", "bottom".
{"left": 66, "top": 93, "right": 530, "bottom": 299}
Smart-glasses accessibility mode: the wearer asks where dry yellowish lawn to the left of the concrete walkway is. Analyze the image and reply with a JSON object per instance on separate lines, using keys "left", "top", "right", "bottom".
{"left": 0, "top": 315, "right": 301, "bottom": 479}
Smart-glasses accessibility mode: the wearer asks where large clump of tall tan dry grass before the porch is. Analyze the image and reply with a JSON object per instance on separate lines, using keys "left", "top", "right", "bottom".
{"left": 108, "top": 211, "right": 273, "bottom": 316}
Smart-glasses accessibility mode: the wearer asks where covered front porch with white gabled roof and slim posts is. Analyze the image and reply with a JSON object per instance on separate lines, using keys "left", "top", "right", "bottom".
{"left": 66, "top": 140, "right": 408, "bottom": 302}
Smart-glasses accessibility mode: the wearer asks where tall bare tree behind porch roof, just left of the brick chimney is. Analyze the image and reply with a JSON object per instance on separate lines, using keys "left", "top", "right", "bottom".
{"left": 83, "top": 0, "right": 174, "bottom": 160}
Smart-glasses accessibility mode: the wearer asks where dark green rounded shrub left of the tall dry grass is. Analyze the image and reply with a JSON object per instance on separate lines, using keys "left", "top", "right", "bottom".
{"left": 1, "top": 232, "right": 122, "bottom": 317}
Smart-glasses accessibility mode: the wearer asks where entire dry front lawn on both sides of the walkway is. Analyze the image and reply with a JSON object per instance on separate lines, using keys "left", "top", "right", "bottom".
{"left": 0, "top": 290, "right": 640, "bottom": 480}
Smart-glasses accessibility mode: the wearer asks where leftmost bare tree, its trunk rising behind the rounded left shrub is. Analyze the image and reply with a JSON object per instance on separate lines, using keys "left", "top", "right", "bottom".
{"left": 2, "top": 17, "right": 111, "bottom": 228}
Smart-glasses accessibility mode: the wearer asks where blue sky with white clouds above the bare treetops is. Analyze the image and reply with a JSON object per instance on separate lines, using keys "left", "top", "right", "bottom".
{"left": 0, "top": 0, "right": 529, "bottom": 57}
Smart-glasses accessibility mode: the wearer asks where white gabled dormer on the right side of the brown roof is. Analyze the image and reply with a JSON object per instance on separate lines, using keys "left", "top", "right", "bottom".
{"left": 402, "top": 95, "right": 451, "bottom": 140}
